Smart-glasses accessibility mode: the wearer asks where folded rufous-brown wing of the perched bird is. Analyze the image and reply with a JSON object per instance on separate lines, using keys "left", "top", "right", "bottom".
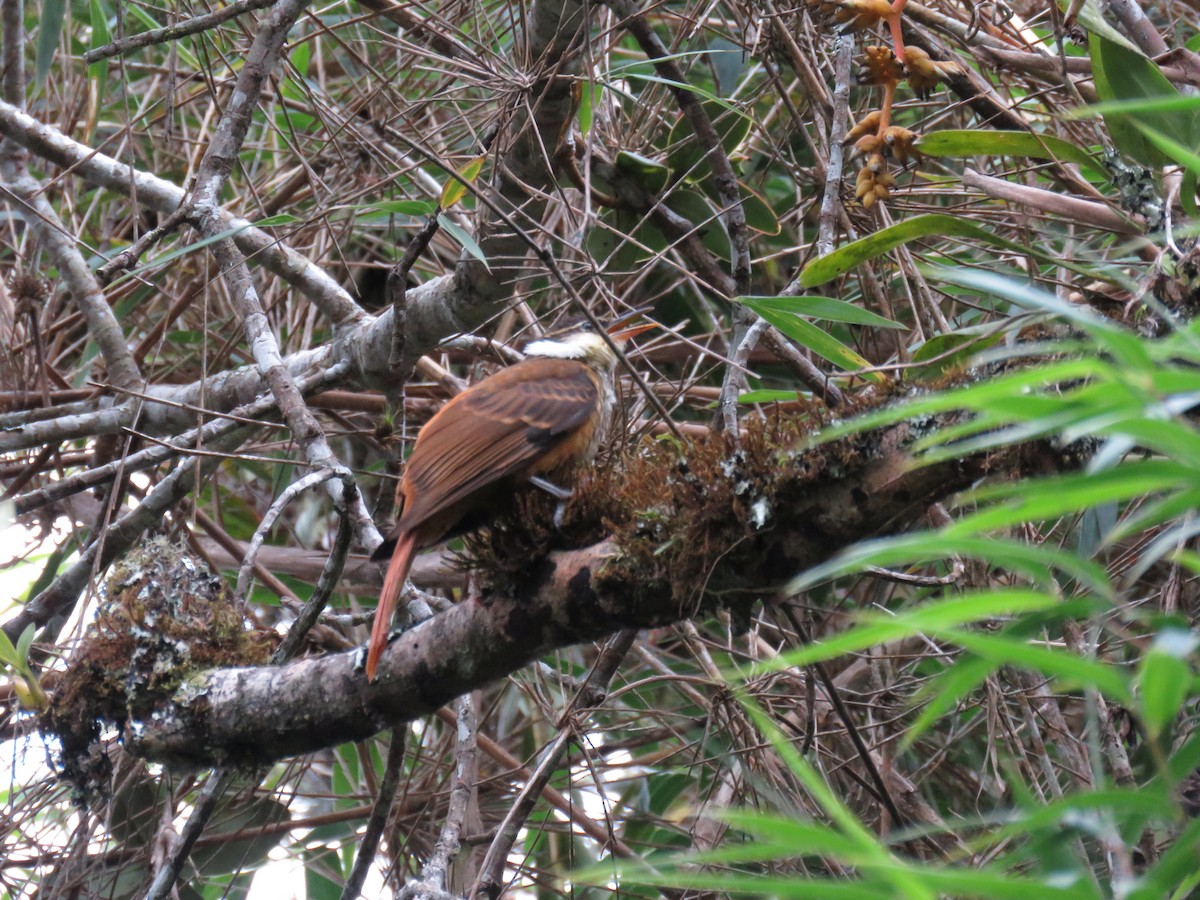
{"left": 396, "top": 358, "right": 599, "bottom": 530}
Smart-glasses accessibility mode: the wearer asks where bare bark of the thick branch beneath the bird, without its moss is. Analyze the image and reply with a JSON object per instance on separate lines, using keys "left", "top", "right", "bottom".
{"left": 127, "top": 425, "right": 1056, "bottom": 764}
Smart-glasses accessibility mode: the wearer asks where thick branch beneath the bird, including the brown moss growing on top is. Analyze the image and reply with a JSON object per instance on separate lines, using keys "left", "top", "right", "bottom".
{"left": 126, "top": 415, "right": 1064, "bottom": 766}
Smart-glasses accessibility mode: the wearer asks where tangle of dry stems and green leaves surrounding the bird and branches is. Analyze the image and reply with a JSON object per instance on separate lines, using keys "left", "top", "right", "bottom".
{"left": 0, "top": 0, "right": 1200, "bottom": 898}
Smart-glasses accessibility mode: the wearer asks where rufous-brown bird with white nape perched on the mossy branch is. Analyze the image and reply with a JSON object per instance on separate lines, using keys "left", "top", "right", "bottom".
{"left": 365, "top": 310, "right": 656, "bottom": 682}
